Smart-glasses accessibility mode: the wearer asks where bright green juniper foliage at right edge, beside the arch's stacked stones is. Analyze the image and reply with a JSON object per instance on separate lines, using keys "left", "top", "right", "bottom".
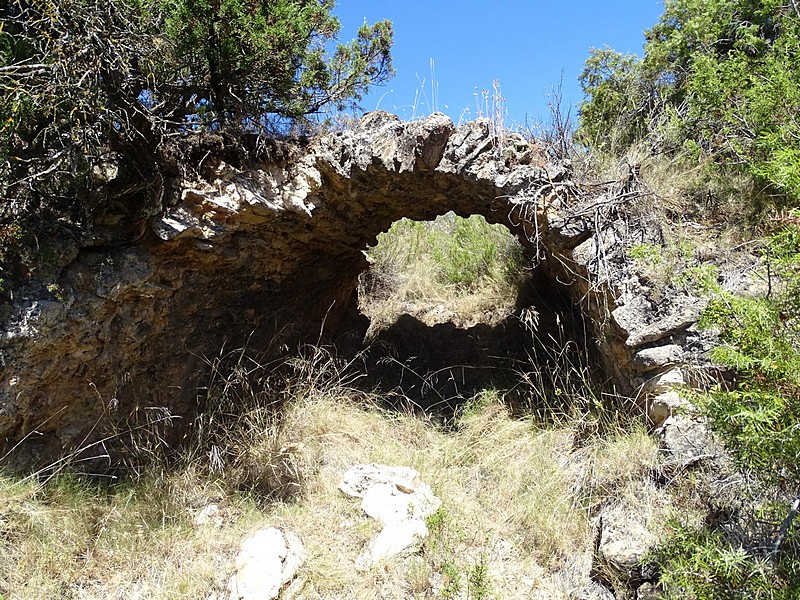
{"left": 699, "top": 225, "right": 800, "bottom": 486}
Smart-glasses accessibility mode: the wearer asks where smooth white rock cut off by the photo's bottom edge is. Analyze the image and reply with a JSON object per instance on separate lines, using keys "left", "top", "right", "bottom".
{"left": 228, "top": 527, "right": 307, "bottom": 600}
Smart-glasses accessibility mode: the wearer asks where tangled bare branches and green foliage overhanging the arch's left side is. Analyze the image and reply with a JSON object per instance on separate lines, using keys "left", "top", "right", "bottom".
{"left": 0, "top": 0, "right": 393, "bottom": 278}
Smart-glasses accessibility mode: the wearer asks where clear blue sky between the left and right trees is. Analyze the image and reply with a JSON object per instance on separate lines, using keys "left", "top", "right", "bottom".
{"left": 334, "top": 0, "right": 664, "bottom": 125}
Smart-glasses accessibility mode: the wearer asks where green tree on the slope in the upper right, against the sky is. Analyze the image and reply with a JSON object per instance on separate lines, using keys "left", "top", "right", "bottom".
{"left": 580, "top": 0, "right": 800, "bottom": 209}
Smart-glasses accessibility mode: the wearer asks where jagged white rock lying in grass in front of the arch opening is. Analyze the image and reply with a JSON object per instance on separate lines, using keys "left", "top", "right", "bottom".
{"left": 339, "top": 463, "right": 442, "bottom": 568}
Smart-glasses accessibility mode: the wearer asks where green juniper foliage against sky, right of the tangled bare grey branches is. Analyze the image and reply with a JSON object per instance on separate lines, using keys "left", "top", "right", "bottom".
{"left": 159, "top": 0, "right": 392, "bottom": 126}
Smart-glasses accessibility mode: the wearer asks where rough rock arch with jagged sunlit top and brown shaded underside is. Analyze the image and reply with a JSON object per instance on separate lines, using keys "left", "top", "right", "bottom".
{"left": 0, "top": 112, "right": 704, "bottom": 457}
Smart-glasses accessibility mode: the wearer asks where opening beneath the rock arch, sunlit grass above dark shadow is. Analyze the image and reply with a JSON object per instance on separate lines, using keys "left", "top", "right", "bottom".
{"left": 346, "top": 212, "right": 592, "bottom": 421}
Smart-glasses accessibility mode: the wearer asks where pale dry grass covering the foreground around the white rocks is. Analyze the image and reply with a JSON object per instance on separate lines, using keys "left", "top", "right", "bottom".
{"left": 0, "top": 358, "right": 658, "bottom": 599}
